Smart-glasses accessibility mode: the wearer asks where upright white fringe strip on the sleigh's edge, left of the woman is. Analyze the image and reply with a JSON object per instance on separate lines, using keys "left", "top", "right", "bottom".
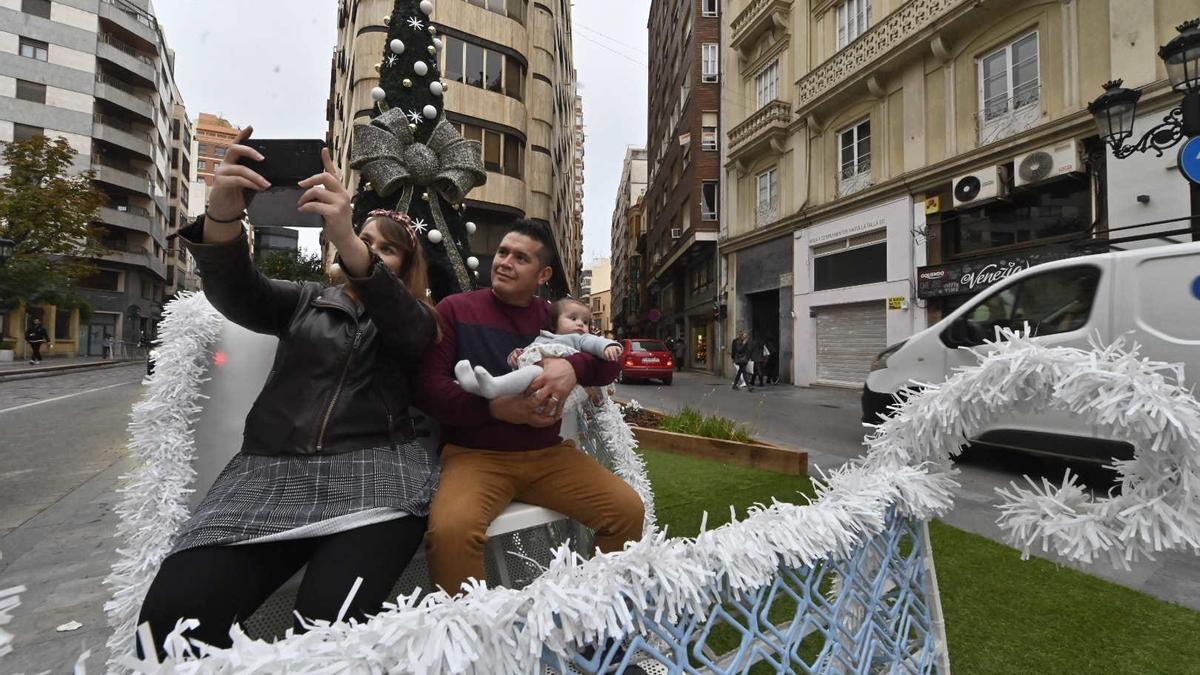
{"left": 104, "top": 293, "right": 223, "bottom": 663}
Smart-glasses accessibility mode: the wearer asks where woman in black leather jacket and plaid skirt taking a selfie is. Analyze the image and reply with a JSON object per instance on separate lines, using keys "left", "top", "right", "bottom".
{"left": 138, "top": 129, "right": 437, "bottom": 653}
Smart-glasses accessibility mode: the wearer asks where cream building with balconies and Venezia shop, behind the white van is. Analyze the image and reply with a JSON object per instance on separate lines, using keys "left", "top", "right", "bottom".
{"left": 720, "top": 0, "right": 1195, "bottom": 387}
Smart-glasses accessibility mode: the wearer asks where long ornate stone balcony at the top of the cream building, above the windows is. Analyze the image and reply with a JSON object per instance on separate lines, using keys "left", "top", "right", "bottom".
{"left": 796, "top": 0, "right": 979, "bottom": 118}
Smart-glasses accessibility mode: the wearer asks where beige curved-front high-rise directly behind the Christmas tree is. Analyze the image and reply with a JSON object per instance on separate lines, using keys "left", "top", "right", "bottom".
{"left": 328, "top": 0, "right": 583, "bottom": 293}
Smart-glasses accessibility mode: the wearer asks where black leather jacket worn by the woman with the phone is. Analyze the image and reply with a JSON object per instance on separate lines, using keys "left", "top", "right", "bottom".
{"left": 179, "top": 217, "right": 436, "bottom": 455}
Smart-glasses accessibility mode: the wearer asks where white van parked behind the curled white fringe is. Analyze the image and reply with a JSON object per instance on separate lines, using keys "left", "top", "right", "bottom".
{"left": 863, "top": 243, "right": 1200, "bottom": 462}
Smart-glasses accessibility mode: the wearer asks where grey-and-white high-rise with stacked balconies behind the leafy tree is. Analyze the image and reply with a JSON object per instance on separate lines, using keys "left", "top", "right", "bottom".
{"left": 0, "top": 0, "right": 187, "bottom": 356}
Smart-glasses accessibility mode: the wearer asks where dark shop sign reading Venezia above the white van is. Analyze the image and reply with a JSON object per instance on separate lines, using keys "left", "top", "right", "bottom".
{"left": 917, "top": 240, "right": 1099, "bottom": 298}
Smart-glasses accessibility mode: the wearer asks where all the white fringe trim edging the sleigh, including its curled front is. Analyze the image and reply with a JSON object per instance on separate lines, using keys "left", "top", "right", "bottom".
{"left": 100, "top": 309, "right": 1200, "bottom": 674}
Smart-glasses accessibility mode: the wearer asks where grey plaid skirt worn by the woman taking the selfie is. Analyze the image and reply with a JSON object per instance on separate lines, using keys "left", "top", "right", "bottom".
{"left": 172, "top": 441, "right": 439, "bottom": 552}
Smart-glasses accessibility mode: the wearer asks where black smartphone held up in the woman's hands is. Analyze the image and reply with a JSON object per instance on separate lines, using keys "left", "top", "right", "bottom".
{"left": 238, "top": 138, "right": 325, "bottom": 227}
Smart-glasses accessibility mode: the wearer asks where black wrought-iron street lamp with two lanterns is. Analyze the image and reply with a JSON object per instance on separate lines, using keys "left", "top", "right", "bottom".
{"left": 1087, "top": 18, "right": 1200, "bottom": 241}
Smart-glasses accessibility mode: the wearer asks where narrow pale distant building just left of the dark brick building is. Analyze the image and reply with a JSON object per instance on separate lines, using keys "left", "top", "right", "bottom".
{"left": 611, "top": 148, "right": 647, "bottom": 338}
